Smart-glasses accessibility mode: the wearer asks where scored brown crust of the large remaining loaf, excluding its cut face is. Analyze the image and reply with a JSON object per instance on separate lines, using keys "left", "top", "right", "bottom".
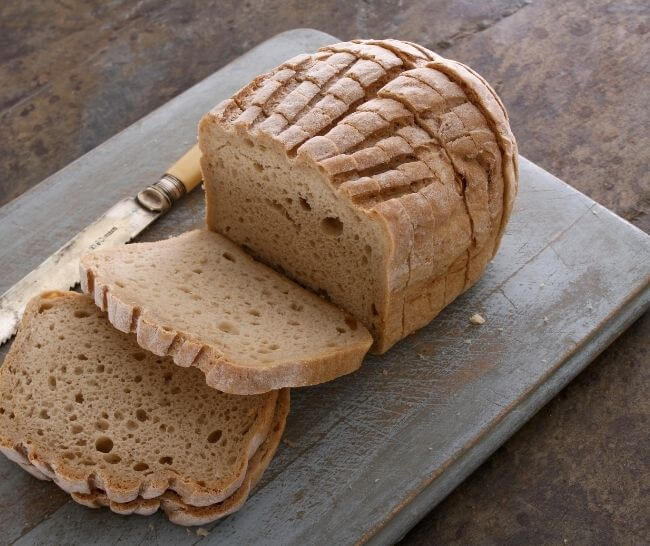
{"left": 199, "top": 40, "right": 518, "bottom": 353}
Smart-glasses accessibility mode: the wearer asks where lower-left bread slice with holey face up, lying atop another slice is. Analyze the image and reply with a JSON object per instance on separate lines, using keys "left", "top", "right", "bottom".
{"left": 0, "top": 292, "right": 277, "bottom": 506}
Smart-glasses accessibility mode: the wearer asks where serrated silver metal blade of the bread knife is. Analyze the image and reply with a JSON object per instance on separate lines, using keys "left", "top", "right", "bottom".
{"left": 0, "top": 197, "right": 162, "bottom": 345}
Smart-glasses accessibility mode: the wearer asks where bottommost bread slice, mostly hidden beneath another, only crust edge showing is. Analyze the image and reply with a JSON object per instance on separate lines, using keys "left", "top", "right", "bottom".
{"left": 72, "top": 389, "right": 289, "bottom": 525}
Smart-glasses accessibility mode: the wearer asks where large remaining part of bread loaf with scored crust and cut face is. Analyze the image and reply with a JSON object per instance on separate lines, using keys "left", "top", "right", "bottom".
{"left": 199, "top": 40, "right": 518, "bottom": 352}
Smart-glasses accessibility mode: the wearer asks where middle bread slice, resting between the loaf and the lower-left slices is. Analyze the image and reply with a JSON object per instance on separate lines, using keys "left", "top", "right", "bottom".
{"left": 81, "top": 230, "right": 372, "bottom": 394}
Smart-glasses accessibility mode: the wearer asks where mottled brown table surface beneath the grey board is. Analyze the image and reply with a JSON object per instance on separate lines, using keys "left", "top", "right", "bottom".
{"left": 0, "top": 0, "right": 650, "bottom": 544}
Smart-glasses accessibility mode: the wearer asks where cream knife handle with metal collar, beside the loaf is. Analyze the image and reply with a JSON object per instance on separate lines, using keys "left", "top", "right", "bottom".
{"left": 137, "top": 144, "right": 201, "bottom": 212}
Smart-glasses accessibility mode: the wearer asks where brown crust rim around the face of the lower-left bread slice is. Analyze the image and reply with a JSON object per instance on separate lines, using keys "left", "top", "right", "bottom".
{"left": 0, "top": 292, "right": 278, "bottom": 506}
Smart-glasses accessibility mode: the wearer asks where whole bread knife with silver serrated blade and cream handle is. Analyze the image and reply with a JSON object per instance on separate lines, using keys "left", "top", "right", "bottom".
{"left": 0, "top": 145, "right": 201, "bottom": 345}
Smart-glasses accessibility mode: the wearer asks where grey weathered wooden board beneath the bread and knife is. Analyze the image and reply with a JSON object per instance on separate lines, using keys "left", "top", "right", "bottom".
{"left": 0, "top": 30, "right": 650, "bottom": 544}
